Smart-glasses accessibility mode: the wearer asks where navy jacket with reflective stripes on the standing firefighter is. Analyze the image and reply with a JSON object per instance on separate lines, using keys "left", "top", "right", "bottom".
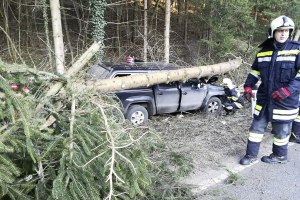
{"left": 244, "top": 40, "right": 300, "bottom": 122}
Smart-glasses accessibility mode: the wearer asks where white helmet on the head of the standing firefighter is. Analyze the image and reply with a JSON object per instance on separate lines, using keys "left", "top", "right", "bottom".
{"left": 269, "top": 15, "right": 295, "bottom": 38}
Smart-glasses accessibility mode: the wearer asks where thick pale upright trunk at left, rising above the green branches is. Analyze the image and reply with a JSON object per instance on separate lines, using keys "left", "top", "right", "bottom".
{"left": 50, "top": 0, "right": 65, "bottom": 74}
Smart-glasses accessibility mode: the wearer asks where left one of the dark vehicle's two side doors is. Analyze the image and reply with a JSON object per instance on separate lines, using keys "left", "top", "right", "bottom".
{"left": 154, "top": 82, "right": 179, "bottom": 114}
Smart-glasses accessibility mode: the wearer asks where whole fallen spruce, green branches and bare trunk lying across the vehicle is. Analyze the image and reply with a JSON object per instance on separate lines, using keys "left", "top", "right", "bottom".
{"left": 0, "top": 55, "right": 241, "bottom": 199}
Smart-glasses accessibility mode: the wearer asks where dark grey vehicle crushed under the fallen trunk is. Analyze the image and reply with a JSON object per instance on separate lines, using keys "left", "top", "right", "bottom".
{"left": 88, "top": 63, "right": 225, "bottom": 125}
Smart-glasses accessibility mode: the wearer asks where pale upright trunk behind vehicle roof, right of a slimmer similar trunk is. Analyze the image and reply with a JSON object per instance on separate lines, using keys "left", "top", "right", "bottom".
{"left": 164, "top": 0, "right": 171, "bottom": 63}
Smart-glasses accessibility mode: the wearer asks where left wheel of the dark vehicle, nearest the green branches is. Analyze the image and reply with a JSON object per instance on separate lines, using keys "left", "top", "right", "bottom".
{"left": 126, "top": 105, "right": 149, "bottom": 125}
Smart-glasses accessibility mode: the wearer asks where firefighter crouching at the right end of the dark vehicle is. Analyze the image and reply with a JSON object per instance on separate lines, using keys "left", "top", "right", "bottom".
{"left": 222, "top": 78, "right": 244, "bottom": 115}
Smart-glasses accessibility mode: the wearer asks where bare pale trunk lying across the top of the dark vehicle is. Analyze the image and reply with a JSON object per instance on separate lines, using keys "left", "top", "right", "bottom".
{"left": 85, "top": 58, "right": 242, "bottom": 92}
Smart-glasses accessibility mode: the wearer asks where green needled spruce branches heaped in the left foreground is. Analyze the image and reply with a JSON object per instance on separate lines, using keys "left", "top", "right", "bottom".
{"left": 0, "top": 63, "right": 151, "bottom": 200}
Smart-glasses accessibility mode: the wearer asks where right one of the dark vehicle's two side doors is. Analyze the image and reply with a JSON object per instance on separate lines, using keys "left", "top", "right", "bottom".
{"left": 179, "top": 80, "right": 207, "bottom": 111}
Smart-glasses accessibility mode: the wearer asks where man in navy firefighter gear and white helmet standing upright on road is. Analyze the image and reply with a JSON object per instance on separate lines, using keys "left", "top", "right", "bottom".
{"left": 240, "top": 16, "right": 300, "bottom": 165}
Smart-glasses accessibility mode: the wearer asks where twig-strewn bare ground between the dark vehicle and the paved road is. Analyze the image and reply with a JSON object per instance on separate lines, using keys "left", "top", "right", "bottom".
{"left": 149, "top": 103, "right": 252, "bottom": 171}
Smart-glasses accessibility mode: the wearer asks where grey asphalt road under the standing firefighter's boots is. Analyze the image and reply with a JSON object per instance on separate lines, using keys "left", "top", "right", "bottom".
{"left": 197, "top": 144, "right": 300, "bottom": 200}
